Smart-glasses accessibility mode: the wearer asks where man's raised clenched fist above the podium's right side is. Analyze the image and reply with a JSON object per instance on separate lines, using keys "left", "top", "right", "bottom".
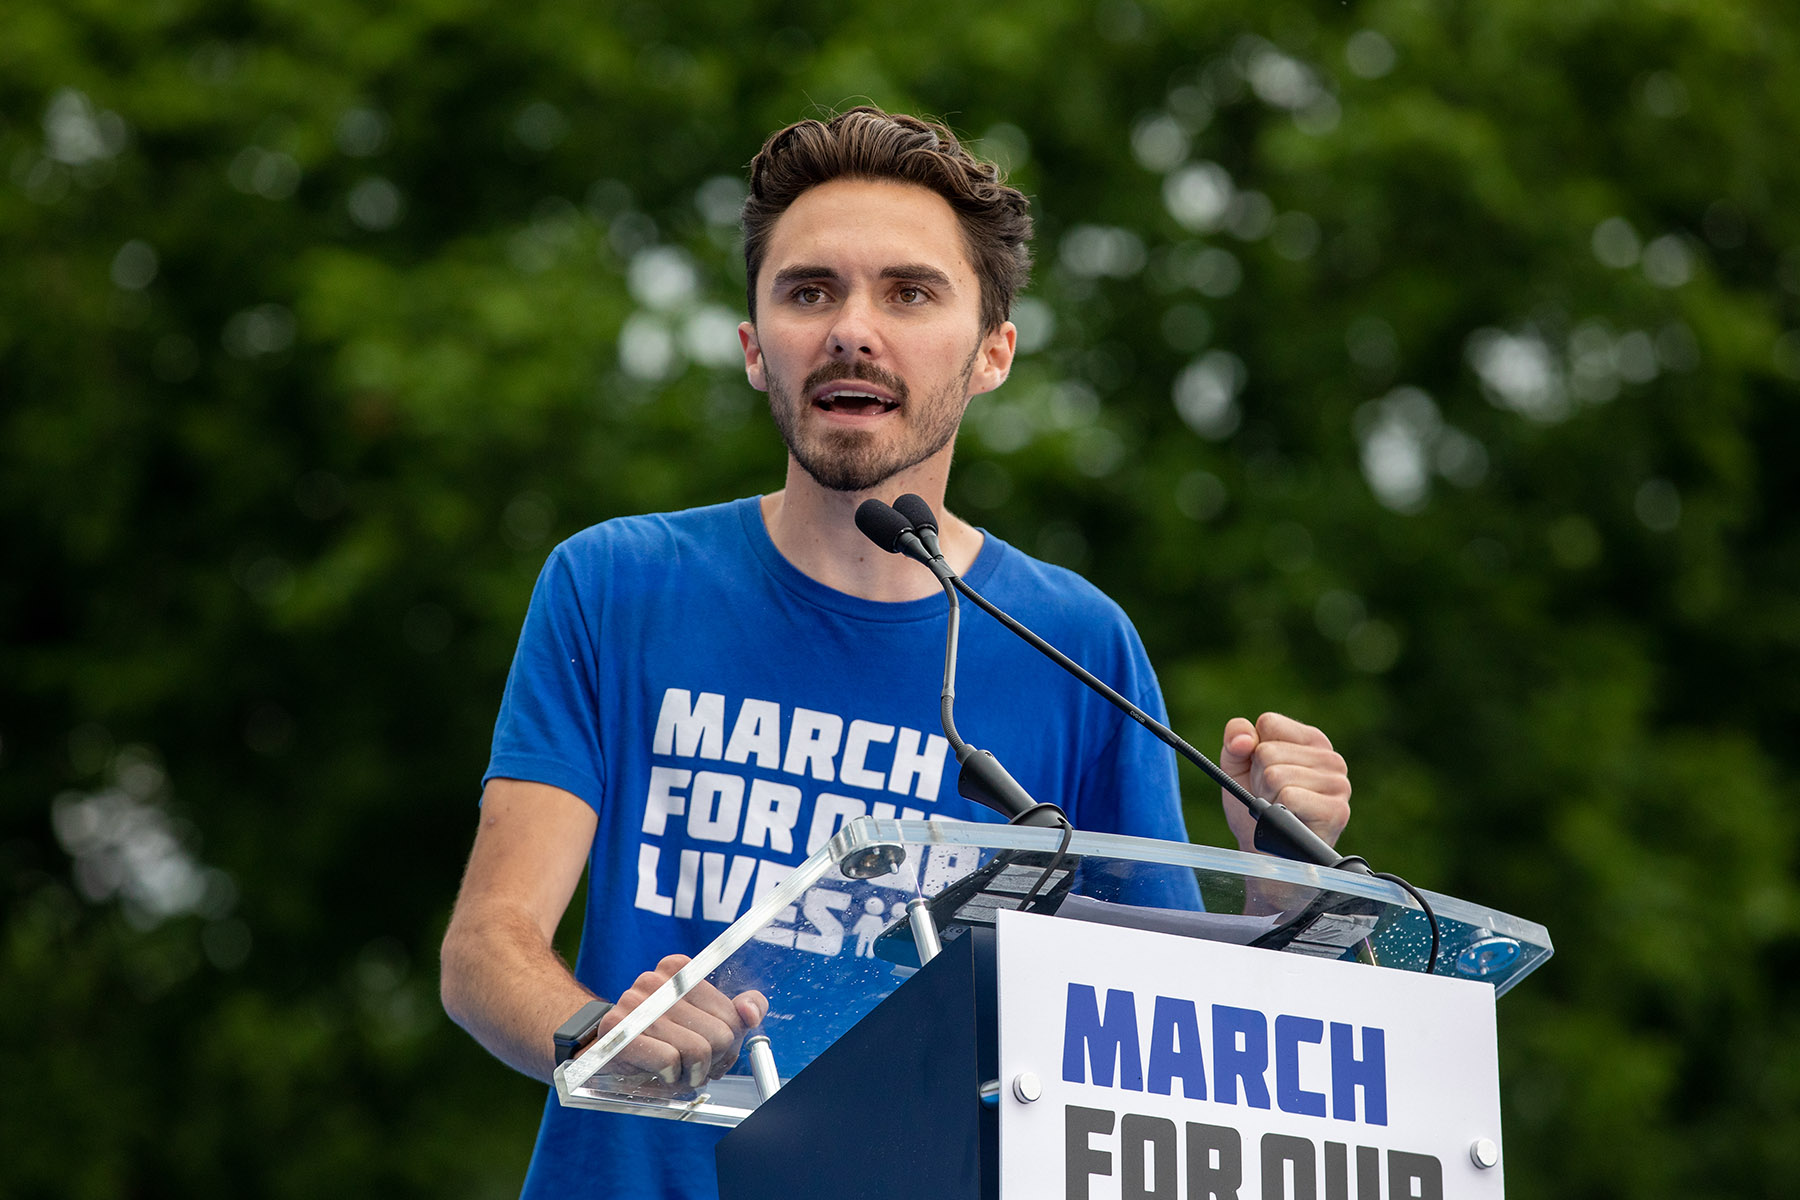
{"left": 1219, "top": 712, "right": 1350, "bottom": 853}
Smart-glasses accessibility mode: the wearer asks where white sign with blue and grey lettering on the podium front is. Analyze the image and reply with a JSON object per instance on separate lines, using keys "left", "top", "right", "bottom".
{"left": 997, "top": 912, "right": 1505, "bottom": 1200}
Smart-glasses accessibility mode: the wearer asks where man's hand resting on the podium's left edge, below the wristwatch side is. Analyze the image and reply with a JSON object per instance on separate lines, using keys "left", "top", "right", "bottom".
{"left": 596, "top": 954, "right": 769, "bottom": 1092}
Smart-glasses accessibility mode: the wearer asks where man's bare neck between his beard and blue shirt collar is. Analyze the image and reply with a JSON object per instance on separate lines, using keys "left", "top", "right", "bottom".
{"left": 761, "top": 455, "right": 983, "bottom": 601}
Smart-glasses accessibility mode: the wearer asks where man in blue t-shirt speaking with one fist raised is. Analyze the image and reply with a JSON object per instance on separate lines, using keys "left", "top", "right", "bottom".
{"left": 443, "top": 108, "right": 1350, "bottom": 1198}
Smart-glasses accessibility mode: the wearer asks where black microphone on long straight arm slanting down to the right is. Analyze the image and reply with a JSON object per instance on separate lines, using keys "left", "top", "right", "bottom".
{"left": 878, "top": 493, "right": 1372, "bottom": 874}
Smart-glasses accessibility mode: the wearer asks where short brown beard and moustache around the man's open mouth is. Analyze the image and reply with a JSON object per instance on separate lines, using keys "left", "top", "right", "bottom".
{"left": 769, "top": 344, "right": 981, "bottom": 491}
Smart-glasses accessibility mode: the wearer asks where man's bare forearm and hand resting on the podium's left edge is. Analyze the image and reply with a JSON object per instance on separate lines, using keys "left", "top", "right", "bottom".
{"left": 441, "top": 779, "right": 769, "bottom": 1087}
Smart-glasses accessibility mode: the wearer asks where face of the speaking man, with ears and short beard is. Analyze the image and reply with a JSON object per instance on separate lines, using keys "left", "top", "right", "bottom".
{"left": 738, "top": 180, "right": 1015, "bottom": 491}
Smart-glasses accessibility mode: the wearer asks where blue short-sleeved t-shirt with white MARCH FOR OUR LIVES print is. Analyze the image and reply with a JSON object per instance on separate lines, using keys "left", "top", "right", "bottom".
{"left": 484, "top": 498, "right": 1186, "bottom": 1200}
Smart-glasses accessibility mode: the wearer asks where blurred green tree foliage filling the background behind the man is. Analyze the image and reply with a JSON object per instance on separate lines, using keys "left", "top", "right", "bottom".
{"left": 0, "top": 0, "right": 1800, "bottom": 1198}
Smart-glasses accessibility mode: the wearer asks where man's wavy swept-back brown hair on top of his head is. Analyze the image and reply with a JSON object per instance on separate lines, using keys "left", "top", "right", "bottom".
{"left": 743, "top": 104, "right": 1031, "bottom": 333}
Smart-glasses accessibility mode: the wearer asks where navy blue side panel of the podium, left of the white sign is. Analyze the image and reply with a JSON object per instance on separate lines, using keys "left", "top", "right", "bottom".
{"left": 716, "top": 928, "right": 999, "bottom": 1200}
